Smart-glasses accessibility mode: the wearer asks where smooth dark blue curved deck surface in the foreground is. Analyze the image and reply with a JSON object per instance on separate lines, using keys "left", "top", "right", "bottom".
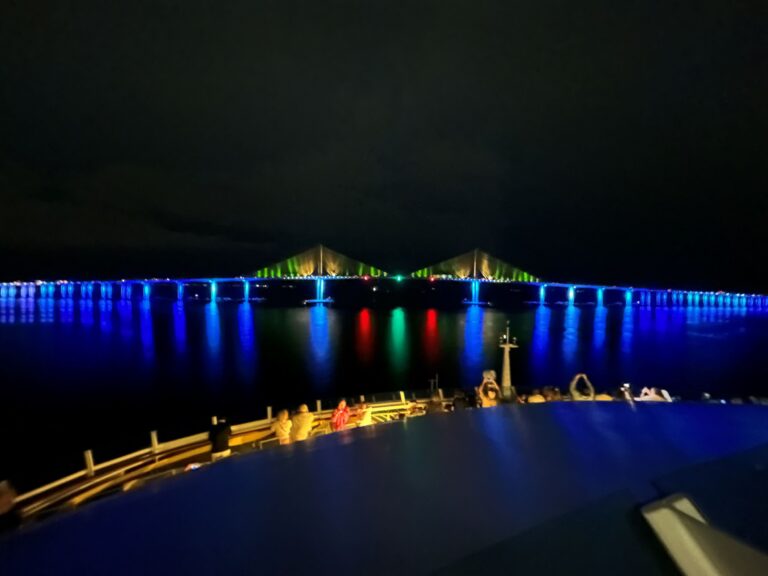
{"left": 0, "top": 402, "right": 768, "bottom": 576}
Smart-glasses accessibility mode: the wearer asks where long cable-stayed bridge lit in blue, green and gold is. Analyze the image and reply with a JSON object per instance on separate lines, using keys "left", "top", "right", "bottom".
{"left": 0, "top": 244, "right": 768, "bottom": 309}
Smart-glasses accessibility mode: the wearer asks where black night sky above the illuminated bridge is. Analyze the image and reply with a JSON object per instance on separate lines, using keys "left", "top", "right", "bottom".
{"left": 0, "top": 0, "right": 768, "bottom": 291}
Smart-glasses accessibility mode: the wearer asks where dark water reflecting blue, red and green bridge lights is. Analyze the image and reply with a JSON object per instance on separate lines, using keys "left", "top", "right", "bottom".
{"left": 0, "top": 299, "right": 768, "bottom": 489}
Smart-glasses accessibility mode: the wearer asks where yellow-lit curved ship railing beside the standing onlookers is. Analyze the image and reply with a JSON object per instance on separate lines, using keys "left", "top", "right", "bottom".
{"left": 15, "top": 390, "right": 448, "bottom": 519}
